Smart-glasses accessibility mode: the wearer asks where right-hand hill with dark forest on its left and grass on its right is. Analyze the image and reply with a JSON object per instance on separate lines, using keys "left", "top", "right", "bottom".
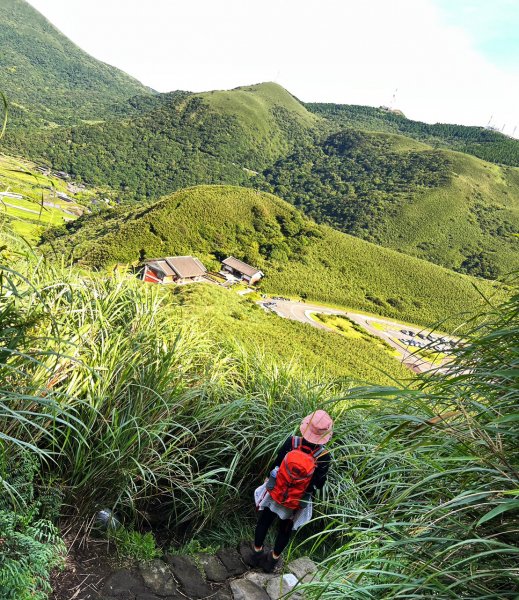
{"left": 262, "top": 129, "right": 519, "bottom": 279}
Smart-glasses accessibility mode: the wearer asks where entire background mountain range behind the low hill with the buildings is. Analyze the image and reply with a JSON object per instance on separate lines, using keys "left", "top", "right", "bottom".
{"left": 0, "top": 0, "right": 519, "bottom": 279}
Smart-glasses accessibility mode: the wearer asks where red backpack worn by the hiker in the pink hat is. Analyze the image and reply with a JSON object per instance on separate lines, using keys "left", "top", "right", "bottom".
{"left": 270, "top": 436, "right": 325, "bottom": 510}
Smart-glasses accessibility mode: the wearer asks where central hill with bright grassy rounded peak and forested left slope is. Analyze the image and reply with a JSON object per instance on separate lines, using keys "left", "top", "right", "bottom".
{"left": 6, "top": 84, "right": 318, "bottom": 200}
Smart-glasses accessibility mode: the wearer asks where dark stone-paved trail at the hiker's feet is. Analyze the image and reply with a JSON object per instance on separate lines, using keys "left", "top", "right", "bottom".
{"left": 52, "top": 542, "right": 317, "bottom": 600}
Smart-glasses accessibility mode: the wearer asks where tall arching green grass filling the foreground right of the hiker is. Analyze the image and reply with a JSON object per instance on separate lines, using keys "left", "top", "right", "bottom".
{"left": 296, "top": 286, "right": 519, "bottom": 598}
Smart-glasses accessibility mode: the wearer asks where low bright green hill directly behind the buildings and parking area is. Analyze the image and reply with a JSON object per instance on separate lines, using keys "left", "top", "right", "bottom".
{"left": 42, "top": 186, "right": 506, "bottom": 324}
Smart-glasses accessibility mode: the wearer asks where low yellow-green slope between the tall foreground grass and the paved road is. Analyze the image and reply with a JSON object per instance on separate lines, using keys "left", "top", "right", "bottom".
{"left": 172, "top": 285, "right": 412, "bottom": 385}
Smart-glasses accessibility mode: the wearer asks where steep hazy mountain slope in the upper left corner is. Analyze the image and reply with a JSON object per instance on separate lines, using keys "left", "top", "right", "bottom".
{"left": 0, "top": 0, "right": 150, "bottom": 126}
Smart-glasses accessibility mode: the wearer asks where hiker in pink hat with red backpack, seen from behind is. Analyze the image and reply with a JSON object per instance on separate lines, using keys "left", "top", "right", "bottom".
{"left": 250, "top": 410, "right": 333, "bottom": 573}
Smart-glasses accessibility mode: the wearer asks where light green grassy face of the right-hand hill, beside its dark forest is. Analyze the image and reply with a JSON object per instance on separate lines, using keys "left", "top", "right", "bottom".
{"left": 375, "top": 152, "right": 519, "bottom": 275}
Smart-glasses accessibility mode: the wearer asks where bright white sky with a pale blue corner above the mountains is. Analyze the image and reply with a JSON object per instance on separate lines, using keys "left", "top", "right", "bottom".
{"left": 29, "top": 0, "right": 519, "bottom": 137}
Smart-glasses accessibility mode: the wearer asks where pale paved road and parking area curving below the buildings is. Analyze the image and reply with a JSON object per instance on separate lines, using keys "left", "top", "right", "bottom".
{"left": 267, "top": 300, "right": 452, "bottom": 373}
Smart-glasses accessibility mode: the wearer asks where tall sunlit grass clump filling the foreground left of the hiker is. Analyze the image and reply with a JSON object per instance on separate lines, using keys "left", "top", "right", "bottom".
{"left": 1, "top": 251, "right": 350, "bottom": 525}
